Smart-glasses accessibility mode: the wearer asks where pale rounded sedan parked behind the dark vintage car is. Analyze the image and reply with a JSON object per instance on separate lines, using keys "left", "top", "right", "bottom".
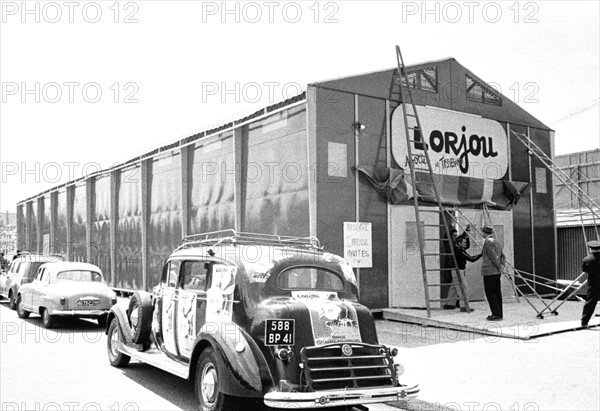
{"left": 16, "top": 262, "right": 117, "bottom": 328}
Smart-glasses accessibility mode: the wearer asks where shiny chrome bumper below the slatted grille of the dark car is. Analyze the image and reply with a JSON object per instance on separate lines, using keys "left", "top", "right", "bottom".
{"left": 264, "top": 385, "right": 419, "bottom": 408}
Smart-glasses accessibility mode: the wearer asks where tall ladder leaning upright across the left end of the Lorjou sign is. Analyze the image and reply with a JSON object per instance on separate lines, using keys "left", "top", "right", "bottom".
{"left": 396, "top": 46, "right": 470, "bottom": 318}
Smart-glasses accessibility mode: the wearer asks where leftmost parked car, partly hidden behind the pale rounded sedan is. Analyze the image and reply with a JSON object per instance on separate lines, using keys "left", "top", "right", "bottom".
{"left": 0, "top": 252, "right": 63, "bottom": 310}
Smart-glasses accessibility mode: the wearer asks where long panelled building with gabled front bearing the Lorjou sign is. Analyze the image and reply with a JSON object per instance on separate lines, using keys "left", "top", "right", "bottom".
{"left": 17, "top": 58, "right": 556, "bottom": 309}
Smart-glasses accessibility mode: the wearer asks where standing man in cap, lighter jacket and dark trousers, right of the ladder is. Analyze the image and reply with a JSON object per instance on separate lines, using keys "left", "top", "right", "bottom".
{"left": 481, "top": 225, "right": 504, "bottom": 321}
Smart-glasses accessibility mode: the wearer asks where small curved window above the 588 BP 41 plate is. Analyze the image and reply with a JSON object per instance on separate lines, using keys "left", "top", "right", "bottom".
{"left": 277, "top": 267, "right": 344, "bottom": 291}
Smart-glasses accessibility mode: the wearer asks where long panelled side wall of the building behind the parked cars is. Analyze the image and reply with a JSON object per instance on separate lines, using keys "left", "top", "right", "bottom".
{"left": 17, "top": 100, "right": 310, "bottom": 290}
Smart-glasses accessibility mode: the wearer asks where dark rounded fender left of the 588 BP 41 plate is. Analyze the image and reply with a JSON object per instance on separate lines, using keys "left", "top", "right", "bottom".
{"left": 189, "top": 323, "right": 273, "bottom": 398}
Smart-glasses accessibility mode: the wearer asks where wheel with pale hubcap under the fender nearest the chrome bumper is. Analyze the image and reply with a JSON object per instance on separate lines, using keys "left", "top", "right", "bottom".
{"left": 194, "top": 348, "right": 244, "bottom": 411}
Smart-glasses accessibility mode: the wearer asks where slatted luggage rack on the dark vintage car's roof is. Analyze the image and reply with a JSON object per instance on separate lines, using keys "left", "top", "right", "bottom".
{"left": 177, "top": 229, "right": 321, "bottom": 250}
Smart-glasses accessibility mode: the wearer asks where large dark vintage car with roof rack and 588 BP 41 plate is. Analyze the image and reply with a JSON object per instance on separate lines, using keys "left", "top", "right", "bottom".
{"left": 107, "top": 230, "right": 419, "bottom": 411}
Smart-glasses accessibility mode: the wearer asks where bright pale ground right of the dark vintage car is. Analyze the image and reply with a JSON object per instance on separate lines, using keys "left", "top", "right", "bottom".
{"left": 377, "top": 310, "right": 600, "bottom": 411}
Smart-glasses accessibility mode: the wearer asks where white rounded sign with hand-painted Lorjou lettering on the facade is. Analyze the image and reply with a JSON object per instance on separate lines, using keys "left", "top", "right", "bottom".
{"left": 392, "top": 106, "right": 508, "bottom": 180}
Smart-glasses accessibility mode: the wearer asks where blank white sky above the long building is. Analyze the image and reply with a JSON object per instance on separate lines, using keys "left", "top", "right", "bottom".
{"left": 0, "top": 0, "right": 600, "bottom": 212}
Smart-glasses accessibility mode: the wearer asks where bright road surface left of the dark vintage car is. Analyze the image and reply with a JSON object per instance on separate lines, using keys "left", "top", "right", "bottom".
{"left": 0, "top": 300, "right": 412, "bottom": 411}
